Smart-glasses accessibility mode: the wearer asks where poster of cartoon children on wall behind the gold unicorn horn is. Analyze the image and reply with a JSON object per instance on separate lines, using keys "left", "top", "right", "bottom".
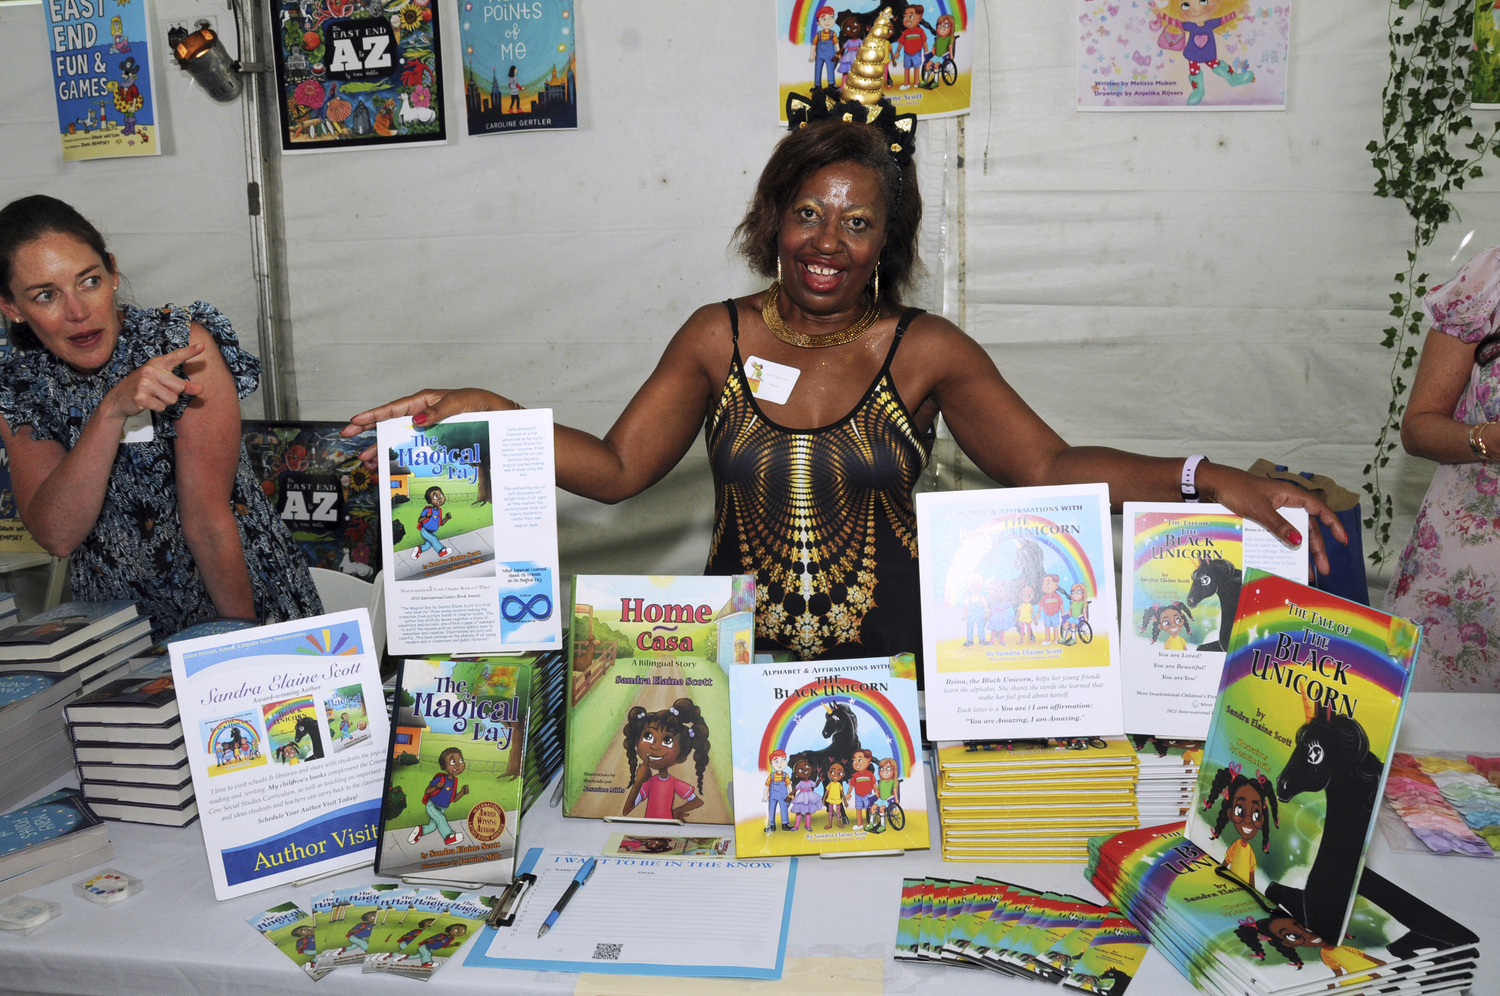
{"left": 776, "top": 0, "right": 978, "bottom": 123}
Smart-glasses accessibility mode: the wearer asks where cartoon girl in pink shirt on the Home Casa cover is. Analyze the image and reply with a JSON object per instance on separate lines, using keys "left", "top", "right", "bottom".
{"left": 621, "top": 699, "right": 708, "bottom": 819}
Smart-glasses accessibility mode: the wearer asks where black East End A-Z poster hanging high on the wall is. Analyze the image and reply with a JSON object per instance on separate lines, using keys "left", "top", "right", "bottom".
{"left": 275, "top": 0, "right": 447, "bottom": 152}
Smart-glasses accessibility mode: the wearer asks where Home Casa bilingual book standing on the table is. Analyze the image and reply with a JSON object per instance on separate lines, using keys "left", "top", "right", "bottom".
{"left": 563, "top": 575, "right": 755, "bottom": 824}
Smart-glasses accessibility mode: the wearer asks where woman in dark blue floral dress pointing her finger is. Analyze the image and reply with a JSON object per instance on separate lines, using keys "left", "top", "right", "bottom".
{"left": 0, "top": 195, "right": 323, "bottom": 638}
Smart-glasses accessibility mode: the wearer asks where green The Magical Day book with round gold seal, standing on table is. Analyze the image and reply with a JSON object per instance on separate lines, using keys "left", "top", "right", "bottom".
{"left": 375, "top": 659, "right": 533, "bottom": 884}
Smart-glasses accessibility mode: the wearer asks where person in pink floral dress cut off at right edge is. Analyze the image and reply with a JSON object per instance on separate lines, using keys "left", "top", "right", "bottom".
{"left": 1385, "top": 246, "right": 1500, "bottom": 692}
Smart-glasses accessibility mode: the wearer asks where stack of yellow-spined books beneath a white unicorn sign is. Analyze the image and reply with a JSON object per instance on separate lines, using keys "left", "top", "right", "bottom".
{"left": 936, "top": 737, "right": 1140, "bottom": 861}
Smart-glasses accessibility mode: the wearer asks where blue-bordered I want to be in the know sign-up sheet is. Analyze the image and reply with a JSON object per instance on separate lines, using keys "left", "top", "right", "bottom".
{"left": 464, "top": 848, "right": 797, "bottom": 980}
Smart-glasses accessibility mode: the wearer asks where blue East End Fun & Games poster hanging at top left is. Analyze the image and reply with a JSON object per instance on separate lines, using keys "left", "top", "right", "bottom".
{"left": 42, "top": 0, "right": 159, "bottom": 162}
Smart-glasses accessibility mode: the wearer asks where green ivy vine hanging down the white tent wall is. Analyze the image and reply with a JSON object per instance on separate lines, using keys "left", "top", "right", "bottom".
{"left": 1364, "top": 0, "right": 1500, "bottom": 567}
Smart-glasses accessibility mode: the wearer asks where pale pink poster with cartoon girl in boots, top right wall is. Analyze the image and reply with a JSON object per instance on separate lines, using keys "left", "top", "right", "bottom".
{"left": 1077, "top": 0, "right": 1292, "bottom": 111}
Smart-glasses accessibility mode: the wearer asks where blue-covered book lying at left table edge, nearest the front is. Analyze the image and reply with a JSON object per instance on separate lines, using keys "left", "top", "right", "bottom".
{"left": 0, "top": 789, "right": 111, "bottom": 899}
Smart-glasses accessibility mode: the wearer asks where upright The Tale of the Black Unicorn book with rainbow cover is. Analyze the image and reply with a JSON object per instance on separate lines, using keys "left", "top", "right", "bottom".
{"left": 1187, "top": 569, "right": 1421, "bottom": 938}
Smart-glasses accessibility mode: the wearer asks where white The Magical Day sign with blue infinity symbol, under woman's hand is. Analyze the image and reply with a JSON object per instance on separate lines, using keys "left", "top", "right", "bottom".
{"left": 375, "top": 408, "right": 563, "bottom": 654}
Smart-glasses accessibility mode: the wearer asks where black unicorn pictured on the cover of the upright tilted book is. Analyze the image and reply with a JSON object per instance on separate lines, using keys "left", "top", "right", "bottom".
{"left": 1266, "top": 698, "right": 1385, "bottom": 939}
